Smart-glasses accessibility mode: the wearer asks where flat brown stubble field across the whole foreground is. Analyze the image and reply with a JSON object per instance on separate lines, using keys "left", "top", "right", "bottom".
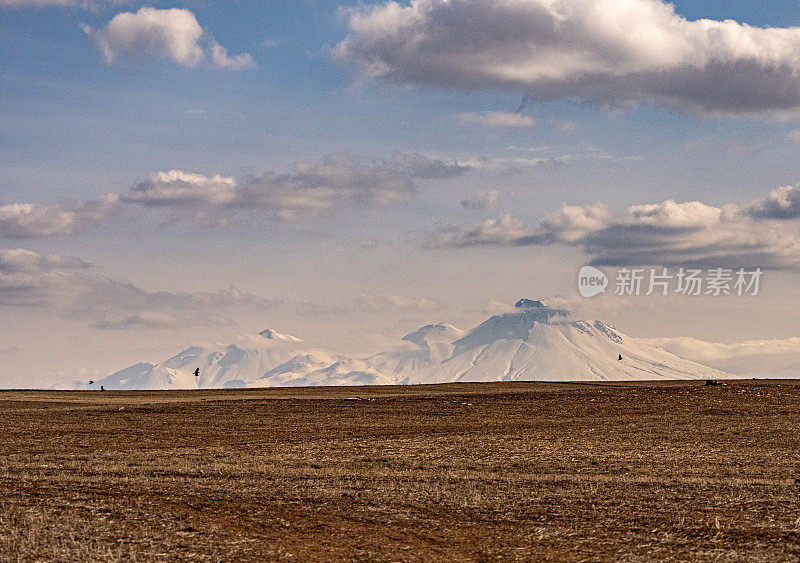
{"left": 0, "top": 382, "right": 800, "bottom": 561}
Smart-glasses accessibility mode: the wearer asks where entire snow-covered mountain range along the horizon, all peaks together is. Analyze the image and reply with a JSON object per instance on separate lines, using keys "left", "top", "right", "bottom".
{"left": 72, "top": 299, "right": 731, "bottom": 389}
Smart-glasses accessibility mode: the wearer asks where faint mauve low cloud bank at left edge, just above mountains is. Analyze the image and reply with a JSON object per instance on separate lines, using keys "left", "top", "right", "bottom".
{"left": 0, "top": 248, "right": 441, "bottom": 332}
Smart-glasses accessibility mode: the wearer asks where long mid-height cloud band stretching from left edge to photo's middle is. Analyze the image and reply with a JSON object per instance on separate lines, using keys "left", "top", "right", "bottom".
{"left": 0, "top": 152, "right": 471, "bottom": 234}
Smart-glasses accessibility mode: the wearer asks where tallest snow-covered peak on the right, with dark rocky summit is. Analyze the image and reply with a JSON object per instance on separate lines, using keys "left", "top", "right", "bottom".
{"left": 407, "top": 299, "right": 729, "bottom": 383}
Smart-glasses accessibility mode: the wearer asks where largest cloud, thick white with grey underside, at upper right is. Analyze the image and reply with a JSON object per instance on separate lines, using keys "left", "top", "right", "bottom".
{"left": 334, "top": 0, "right": 800, "bottom": 115}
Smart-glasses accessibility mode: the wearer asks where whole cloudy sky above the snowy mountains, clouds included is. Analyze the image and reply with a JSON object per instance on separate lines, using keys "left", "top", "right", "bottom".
{"left": 0, "top": 0, "right": 800, "bottom": 387}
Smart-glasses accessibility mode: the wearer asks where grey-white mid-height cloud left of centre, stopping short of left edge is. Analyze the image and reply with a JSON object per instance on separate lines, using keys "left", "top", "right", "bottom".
{"left": 121, "top": 154, "right": 424, "bottom": 226}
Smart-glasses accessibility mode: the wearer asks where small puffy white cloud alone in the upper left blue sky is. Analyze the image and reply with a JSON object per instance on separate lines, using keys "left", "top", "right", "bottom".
{"left": 84, "top": 6, "right": 253, "bottom": 70}
